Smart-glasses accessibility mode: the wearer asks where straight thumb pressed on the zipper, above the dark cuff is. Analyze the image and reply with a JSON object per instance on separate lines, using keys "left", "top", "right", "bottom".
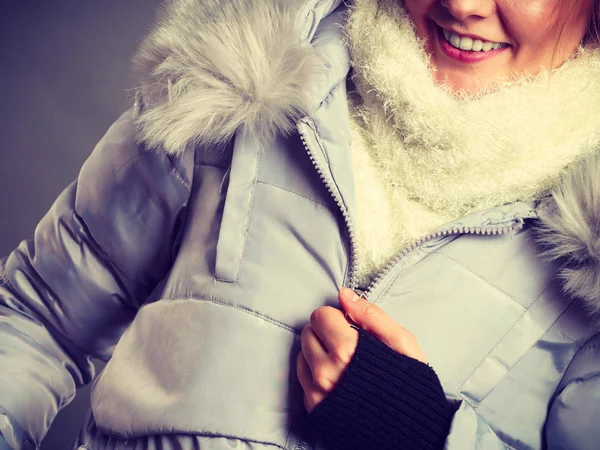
{"left": 338, "top": 288, "right": 425, "bottom": 363}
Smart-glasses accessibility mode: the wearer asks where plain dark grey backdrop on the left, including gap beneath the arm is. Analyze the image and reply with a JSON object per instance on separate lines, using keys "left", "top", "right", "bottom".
{"left": 0, "top": 0, "right": 159, "bottom": 450}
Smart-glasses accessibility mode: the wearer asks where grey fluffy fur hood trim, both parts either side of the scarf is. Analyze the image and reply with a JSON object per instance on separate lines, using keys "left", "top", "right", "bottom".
{"left": 135, "top": 0, "right": 600, "bottom": 324}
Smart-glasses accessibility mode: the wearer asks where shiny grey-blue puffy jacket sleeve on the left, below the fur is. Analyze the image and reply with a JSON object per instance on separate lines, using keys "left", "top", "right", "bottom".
{"left": 0, "top": 112, "right": 193, "bottom": 450}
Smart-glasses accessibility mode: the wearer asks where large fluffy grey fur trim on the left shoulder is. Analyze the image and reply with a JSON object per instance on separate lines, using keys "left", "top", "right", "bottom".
{"left": 134, "top": 0, "right": 323, "bottom": 154}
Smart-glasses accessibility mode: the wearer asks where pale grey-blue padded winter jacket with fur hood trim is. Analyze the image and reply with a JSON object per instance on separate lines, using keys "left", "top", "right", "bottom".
{"left": 0, "top": 0, "right": 600, "bottom": 450}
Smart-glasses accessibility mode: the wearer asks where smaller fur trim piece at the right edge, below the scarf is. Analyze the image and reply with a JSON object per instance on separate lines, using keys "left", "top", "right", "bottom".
{"left": 536, "top": 153, "right": 600, "bottom": 323}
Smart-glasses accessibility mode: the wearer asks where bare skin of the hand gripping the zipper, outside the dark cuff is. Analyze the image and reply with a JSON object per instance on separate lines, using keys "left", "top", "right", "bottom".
{"left": 296, "top": 288, "right": 426, "bottom": 413}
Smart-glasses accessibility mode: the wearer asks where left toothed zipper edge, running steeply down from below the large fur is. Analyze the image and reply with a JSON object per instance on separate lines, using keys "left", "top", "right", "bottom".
{"left": 298, "top": 119, "right": 358, "bottom": 290}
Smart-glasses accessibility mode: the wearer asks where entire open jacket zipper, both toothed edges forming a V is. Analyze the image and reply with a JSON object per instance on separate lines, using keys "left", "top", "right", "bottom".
{"left": 298, "top": 119, "right": 524, "bottom": 300}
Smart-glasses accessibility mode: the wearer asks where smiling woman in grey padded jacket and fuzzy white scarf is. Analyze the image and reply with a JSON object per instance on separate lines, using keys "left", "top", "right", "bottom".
{"left": 0, "top": 0, "right": 600, "bottom": 450}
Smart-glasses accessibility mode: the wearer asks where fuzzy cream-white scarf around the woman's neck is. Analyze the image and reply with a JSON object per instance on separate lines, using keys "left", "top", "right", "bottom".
{"left": 346, "top": 0, "right": 600, "bottom": 284}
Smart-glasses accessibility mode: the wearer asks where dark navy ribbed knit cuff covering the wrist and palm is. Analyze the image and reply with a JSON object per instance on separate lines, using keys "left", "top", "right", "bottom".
{"left": 308, "top": 330, "right": 454, "bottom": 450}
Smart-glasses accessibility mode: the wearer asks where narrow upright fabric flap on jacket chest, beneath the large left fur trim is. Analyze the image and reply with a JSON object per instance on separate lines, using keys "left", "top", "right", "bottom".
{"left": 215, "top": 132, "right": 261, "bottom": 283}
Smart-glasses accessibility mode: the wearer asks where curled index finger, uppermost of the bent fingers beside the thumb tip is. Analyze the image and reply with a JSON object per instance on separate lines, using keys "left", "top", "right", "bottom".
{"left": 310, "top": 306, "right": 358, "bottom": 354}
